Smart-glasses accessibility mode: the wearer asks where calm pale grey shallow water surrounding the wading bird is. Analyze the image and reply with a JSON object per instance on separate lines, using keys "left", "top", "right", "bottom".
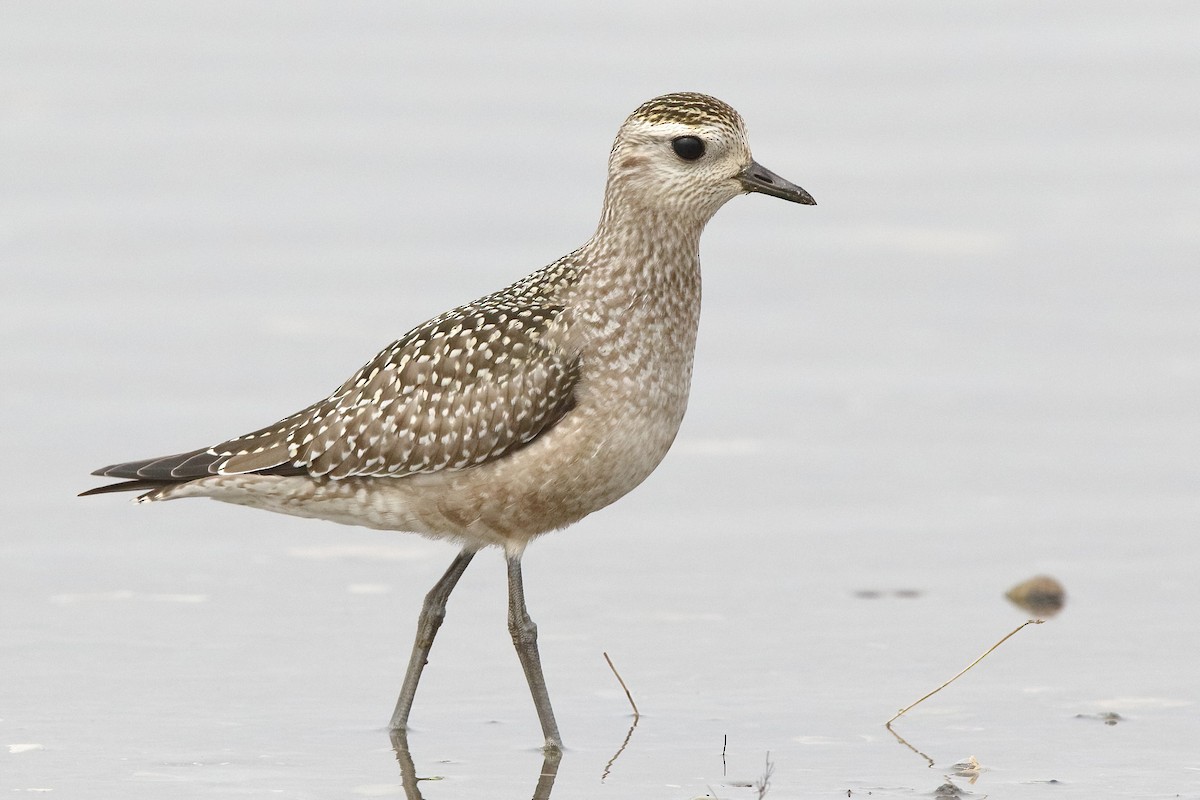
{"left": 0, "top": 2, "right": 1200, "bottom": 800}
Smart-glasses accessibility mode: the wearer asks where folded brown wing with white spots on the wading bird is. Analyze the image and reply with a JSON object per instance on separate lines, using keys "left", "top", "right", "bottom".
{"left": 95, "top": 296, "right": 578, "bottom": 488}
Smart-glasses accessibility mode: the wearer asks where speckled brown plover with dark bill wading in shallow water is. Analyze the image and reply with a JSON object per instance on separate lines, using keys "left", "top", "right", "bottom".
{"left": 82, "top": 92, "right": 816, "bottom": 752}
